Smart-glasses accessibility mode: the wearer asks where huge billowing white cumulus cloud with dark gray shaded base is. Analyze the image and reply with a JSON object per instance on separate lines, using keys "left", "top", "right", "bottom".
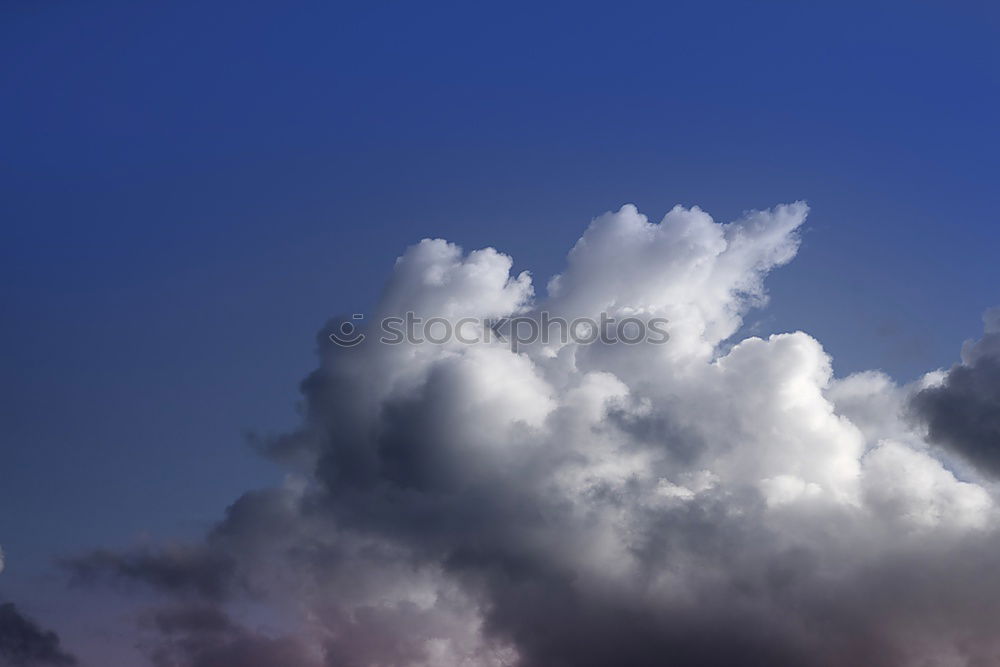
{"left": 72, "top": 203, "right": 1000, "bottom": 667}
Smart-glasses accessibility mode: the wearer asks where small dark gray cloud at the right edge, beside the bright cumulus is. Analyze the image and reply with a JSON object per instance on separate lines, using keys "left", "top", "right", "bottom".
{"left": 913, "top": 308, "right": 1000, "bottom": 475}
